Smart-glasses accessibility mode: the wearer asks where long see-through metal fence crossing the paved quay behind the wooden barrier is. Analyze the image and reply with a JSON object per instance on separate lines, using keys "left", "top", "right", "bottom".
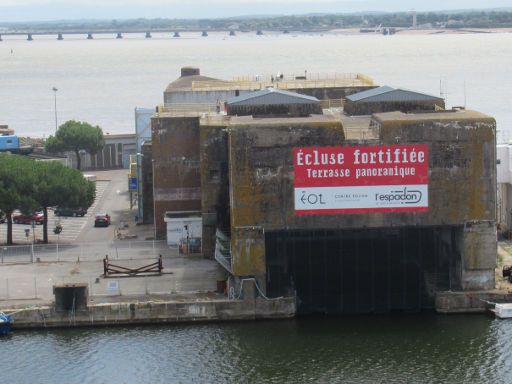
{"left": 0, "top": 240, "right": 170, "bottom": 264}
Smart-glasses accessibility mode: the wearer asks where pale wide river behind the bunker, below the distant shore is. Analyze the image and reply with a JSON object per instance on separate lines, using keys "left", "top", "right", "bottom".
{"left": 0, "top": 33, "right": 512, "bottom": 138}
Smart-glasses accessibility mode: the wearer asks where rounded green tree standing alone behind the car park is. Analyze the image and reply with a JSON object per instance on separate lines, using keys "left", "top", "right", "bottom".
{"left": 46, "top": 120, "right": 105, "bottom": 170}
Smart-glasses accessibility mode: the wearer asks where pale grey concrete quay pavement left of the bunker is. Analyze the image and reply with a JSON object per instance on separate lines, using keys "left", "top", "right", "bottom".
{"left": 0, "top": 170, "right": 227, "bottom": 309}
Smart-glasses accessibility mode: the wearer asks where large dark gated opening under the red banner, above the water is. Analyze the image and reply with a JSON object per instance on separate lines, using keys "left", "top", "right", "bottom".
{"left": 265, "top": 227, "right": 462, "bottom": 314}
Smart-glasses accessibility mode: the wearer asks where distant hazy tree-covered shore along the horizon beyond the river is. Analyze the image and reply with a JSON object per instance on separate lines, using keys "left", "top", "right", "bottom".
{"left": 0, "top": 10, "right": 512, "bottom": 32}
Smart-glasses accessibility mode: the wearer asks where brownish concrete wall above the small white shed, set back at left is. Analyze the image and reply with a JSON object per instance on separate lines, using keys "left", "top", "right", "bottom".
{"left": 151, "top": 115, "right": 201, "bottom": 239}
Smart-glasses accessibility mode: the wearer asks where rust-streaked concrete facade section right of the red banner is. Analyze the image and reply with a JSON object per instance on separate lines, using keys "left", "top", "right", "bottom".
{"left": 376, "top": 112, "right": 496, "bottom": 225}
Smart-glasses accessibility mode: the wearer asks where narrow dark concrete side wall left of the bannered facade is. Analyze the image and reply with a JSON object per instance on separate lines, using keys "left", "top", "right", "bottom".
{"left": 200, "top": 125, "right": 230, "bottom": 258}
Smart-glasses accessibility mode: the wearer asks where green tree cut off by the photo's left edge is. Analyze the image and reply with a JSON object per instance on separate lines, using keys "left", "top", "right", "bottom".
{"left": 0, "top": 154, "right": 38, "bottom": 245}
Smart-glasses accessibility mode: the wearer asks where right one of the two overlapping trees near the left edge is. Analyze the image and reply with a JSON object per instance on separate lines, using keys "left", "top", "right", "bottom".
{"left": 34, "top": 161, "right": 96, "bottom": 244}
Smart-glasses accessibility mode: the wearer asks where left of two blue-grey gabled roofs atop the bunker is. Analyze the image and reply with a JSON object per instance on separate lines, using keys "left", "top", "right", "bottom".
{"left": 226, "top": 88, "right": 320, "bottom": 106}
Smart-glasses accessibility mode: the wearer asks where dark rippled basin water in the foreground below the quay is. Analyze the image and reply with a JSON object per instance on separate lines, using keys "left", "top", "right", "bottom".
{"left": 0, "top": 315, "right": 512, "bottom": 384}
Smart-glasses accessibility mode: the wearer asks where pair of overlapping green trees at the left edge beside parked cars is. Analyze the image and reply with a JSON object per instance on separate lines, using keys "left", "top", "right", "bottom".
{"left": 0, "top": 153, "right": 96, "bottom": 245}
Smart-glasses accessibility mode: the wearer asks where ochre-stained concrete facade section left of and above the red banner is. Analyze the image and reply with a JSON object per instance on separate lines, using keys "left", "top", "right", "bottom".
{"left": 229, "top": 119, "right": 344, "bottom": 276}
